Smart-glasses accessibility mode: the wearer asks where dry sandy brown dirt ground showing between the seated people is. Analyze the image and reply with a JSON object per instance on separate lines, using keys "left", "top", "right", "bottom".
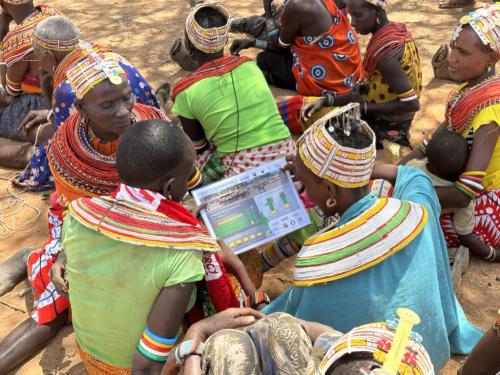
{"left": 0, "top": 0, "right": 500, "bottom": 375}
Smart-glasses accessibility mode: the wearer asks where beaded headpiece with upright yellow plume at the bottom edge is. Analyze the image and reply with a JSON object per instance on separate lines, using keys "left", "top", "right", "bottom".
{"left": 319, "top": 308, "right": 434, "bottom": 375}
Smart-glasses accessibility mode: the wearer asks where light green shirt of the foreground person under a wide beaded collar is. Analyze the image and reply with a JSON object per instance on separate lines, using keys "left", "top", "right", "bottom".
{"left": 62, "top": 214, "right": 204, "bottom": 368}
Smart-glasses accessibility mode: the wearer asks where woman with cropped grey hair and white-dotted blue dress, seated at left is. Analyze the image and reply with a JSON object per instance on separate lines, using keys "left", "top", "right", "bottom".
{"left": 10, "top": 16, "right": 159, "bottom": 191}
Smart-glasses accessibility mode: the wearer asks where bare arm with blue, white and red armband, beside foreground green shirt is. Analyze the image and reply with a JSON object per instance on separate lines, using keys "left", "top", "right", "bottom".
{"left": 132, "top": 283, "right": 194, "bottom": 375}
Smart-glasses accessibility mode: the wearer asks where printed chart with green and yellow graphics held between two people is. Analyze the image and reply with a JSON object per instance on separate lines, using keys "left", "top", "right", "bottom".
{"left": 193, "top": 159, "right": 310, "bottom": 254}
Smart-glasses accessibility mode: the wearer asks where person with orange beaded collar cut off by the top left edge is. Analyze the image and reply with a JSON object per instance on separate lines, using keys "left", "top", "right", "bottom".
{"left": 0, "top": 0, "right": 59, "bottom": 164}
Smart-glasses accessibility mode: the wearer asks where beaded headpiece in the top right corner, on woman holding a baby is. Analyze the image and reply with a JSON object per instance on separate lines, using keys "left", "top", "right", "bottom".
{"left": 451, "top": 4, "right": 500, "bottom": 52}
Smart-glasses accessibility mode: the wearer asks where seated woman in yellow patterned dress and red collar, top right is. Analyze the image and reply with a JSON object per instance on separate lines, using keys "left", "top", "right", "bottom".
{"left": 304, "top": 0, "right": 422, "bottom": 147}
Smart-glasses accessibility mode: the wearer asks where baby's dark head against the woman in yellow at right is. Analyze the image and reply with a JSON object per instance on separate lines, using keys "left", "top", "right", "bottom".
{"left": 426, "top": 129, "right": 469, "bottom": 181}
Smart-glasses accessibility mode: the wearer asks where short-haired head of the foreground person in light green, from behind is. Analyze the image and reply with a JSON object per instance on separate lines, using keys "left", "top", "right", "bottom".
{"left": 116, "top": 120, "right": 196, "bottom": 202}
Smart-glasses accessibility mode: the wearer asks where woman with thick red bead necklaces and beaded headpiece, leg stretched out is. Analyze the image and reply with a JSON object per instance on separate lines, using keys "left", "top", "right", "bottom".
{"left": 0, "top": 53, "right": 164, "bottom": 373}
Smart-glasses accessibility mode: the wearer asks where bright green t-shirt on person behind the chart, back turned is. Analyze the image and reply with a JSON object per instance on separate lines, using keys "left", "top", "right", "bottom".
{"left": 172, "top": 61, "right": 290, "bottom": 155}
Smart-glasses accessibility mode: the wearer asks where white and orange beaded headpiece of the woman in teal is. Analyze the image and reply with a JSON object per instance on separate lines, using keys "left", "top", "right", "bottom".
{"left": 298, "top": 103, "right": 377, "bottom": 188}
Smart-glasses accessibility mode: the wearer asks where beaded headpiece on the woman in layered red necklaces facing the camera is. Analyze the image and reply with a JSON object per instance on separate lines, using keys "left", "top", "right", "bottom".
{"left": 66, "top": 50, "right": 125, "bottom": 99}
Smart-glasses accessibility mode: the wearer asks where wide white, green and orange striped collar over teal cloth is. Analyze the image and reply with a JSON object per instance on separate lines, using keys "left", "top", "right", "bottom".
{"left": 294, "top": 198, "right": 427, "bottom": 286}
